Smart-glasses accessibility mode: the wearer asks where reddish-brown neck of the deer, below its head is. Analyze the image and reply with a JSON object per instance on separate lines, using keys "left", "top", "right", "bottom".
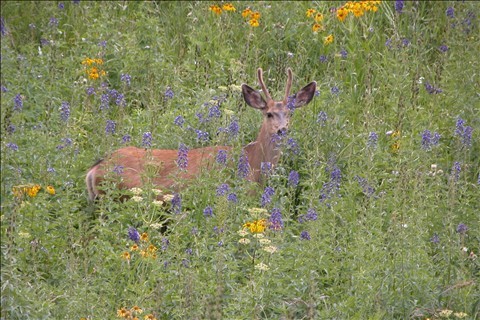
{"left": 243, "top": 126, "right": 280, "bottom": 182}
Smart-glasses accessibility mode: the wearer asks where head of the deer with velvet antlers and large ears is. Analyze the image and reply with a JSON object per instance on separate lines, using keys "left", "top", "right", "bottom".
{"left": 242, "top": 68, "right": 317, "bottom": 135}
